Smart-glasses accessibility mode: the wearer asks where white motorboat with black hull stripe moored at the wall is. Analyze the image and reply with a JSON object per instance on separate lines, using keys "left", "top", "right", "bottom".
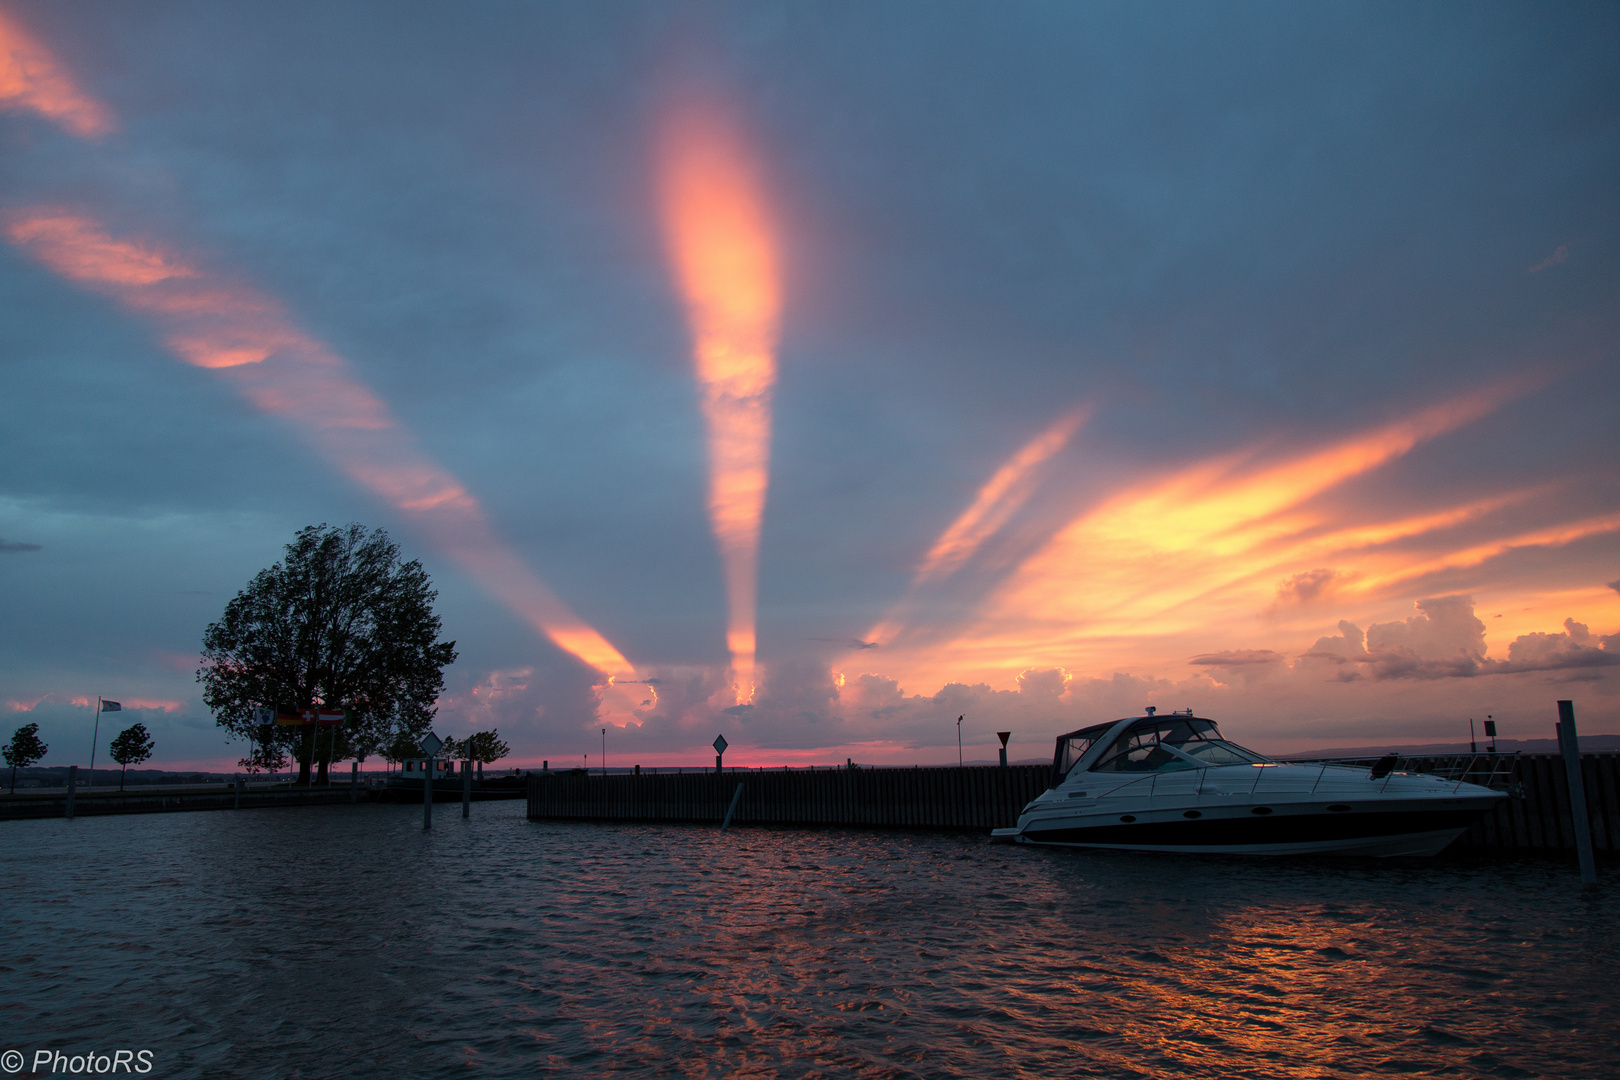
{"left": 991, "top": 709, "right": 1507, "bottom": 855}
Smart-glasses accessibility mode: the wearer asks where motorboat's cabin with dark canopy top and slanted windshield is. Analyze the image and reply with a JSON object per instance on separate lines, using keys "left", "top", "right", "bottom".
{"left": 1051, "top": 709, "right": 1272, "bottom": 787}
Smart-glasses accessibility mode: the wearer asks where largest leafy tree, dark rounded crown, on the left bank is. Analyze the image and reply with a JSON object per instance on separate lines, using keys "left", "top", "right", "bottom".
{"left": 198, "top": 525, "right": 455, "bottom": 784}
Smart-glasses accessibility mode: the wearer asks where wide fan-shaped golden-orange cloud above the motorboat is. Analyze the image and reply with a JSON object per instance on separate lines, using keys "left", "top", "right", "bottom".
{"left": 889, "top": 384, "right": 1568, "bottom": 682}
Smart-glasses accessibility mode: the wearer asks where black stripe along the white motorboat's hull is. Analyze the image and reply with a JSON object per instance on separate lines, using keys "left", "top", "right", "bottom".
{"left": 1024, "top": 810, "right": 1484, "bottom": 847}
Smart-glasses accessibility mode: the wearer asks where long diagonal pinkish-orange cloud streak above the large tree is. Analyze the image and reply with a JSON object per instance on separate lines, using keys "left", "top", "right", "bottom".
{"left": 5, "top": 209, "right": 633, "bottom": 683}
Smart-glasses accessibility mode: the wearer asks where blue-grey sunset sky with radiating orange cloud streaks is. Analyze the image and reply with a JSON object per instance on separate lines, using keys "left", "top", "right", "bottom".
{"left": 0, "top": 0, "right": 1620, "bottom": 771}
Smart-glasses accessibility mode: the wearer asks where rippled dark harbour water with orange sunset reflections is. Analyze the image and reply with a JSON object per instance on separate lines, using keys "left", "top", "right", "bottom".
{"left": 0, "top": 801, "right": 1620, "bottom": 1078}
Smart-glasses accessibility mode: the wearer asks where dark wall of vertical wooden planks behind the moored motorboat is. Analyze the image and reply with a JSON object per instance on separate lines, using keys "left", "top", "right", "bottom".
{"left": 528, "top": 753, "right": 1620, "bottom": 855}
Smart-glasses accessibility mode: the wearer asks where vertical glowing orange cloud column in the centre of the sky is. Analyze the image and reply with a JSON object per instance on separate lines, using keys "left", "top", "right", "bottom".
{"left": 659, "top": 101, "right": 781, "bottom": 701}
